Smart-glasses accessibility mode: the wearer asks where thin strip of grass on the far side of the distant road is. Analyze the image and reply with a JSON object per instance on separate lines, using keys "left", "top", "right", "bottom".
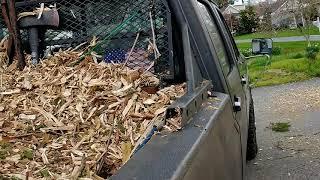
{"left": 235, "top": 27, "right": 320, "bottom": 40}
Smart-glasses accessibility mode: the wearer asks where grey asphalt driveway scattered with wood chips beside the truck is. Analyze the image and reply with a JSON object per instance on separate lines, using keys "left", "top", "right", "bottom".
{"left": 246, "top": 79, "right": 320, "bottom": 180}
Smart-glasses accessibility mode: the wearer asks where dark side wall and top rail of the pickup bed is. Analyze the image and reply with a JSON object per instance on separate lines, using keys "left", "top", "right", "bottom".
{"left": 111, "top": 93, "right": 242, "bottom": 180}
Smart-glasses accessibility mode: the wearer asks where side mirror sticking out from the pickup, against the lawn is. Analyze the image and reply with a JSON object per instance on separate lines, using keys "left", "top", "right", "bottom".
{"left": 252, "top": 38, "right": 273, "bottom": 55}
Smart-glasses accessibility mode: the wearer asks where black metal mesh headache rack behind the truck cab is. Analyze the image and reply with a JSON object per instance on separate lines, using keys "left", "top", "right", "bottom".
{"left": 0, "top": 0, "right": 174, "bottom": 79}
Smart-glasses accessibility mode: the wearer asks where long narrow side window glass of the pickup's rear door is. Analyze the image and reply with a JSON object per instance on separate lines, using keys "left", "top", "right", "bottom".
{"left": 198, "top": 1, "right": 231, "bottom": 75}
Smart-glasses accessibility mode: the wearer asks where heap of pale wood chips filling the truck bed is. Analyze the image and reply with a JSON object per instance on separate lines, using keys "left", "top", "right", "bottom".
{"left": 0, "top": 47, "right": 185, "bottom": 179}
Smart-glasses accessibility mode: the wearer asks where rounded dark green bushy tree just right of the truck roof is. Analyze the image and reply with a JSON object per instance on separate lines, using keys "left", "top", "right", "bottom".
{"left": 239, "top": 6, "right": 258, "bottom": 34}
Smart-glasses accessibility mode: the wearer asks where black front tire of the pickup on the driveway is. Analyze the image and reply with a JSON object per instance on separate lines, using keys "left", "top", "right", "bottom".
{"left": 247, "top": 98, "right": 258, "bottom": 161}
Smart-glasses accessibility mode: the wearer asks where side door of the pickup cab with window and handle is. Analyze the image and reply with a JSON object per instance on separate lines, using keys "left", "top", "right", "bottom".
{"left": 199, "top": 0, "right": 248, "bottom": 177}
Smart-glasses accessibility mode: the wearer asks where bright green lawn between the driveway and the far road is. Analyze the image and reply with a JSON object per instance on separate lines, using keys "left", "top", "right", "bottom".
{"left": 238, "top": 42, "right": 320, "bottom": 87}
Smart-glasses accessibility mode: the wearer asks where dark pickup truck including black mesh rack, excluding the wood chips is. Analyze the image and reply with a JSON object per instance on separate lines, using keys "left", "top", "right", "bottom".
{"left": 1, "top": 0, "right": 258, "bottom": 180}
